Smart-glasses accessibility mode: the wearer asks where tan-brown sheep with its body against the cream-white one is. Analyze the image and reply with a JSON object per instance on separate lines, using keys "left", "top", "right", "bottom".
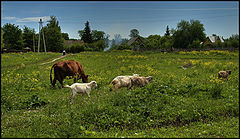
{"left": 131, "top": 76, "right": 153, "bottom": 87}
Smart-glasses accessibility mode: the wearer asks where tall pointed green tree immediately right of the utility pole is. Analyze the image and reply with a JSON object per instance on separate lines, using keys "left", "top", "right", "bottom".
{"left": 43, "top": 16, "right": 64, "bottom": 52}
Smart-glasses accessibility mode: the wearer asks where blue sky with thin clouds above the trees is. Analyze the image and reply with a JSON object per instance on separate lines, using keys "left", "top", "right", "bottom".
{"left": 1, "top": 1, "right": 239, "bottom": 39}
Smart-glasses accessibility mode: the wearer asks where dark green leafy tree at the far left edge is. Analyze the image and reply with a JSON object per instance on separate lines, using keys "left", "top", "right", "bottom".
{"left": 2, "top": 23, "right": 23, "bottom": 50}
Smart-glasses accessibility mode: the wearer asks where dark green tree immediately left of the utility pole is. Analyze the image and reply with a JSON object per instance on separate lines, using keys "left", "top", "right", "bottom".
{"left": 23, "top": 26, "right": 34, "bottom": 50}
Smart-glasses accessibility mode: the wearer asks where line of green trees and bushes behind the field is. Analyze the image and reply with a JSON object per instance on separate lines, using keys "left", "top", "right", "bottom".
{"left": 1, "top": 16, "right": 239, "bottom": 53}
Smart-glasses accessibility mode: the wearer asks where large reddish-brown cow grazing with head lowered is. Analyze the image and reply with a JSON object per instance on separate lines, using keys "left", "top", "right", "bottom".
{"left": 50, "top": 60, "right": 88, "bottom": 88}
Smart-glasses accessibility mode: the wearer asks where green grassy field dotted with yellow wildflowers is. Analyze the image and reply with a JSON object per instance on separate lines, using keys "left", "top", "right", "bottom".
{"left": 1, "top": 50, "right": 239, "bottom": 138}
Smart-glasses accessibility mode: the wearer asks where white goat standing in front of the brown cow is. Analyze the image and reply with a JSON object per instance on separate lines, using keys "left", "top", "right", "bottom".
{"left": 64, "top": 81, "right": 97, "bottom": 104}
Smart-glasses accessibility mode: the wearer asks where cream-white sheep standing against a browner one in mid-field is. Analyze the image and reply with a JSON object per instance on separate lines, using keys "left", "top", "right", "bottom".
{"left": 111, "top": 74, "right": 139, "bottom": 91}
